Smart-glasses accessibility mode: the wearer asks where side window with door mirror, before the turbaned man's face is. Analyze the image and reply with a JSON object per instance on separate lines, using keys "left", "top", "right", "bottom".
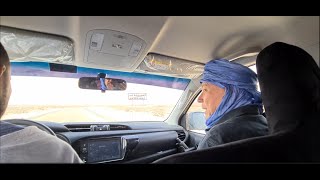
{"left": 186, "top": 94, "right": 206, "bottom": 134}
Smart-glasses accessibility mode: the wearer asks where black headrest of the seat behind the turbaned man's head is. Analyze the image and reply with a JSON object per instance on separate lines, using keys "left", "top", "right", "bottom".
{"left": 256, "top": 42, "right": 320, "bottom": 133}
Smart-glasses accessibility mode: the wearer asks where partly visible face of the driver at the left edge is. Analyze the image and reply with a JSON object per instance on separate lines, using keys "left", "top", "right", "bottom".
{"left": 0, "top": 62, "right": 11, "bottom": 118}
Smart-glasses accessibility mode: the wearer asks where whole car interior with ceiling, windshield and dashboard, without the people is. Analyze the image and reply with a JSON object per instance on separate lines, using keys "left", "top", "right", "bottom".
{"left": 0, "top": 16, "right": 320, "bottom": 164}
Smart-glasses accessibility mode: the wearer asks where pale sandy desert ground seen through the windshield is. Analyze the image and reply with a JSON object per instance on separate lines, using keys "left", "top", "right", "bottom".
{"left": 2, "top": 105, "right": 173, "bottom": 122}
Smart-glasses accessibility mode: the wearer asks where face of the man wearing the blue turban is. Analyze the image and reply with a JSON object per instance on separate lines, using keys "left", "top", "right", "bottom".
{"left": 198, "top": 83, "right": 225, "bottom": 119}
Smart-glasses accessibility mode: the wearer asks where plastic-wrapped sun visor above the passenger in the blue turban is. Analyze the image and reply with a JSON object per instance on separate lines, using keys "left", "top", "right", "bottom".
{"left": 135, "top": 53, "right": 204, "bottom": 79}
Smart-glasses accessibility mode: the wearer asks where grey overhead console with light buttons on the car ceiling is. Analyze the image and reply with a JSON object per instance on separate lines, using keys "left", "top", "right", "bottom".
{"left": 84, "top": 29, "right": 146, "bottom": 70}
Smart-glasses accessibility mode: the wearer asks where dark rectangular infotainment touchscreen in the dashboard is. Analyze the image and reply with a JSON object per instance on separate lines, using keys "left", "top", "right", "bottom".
{"left": 87, "top": 138, "right": 122, "bottom": 163}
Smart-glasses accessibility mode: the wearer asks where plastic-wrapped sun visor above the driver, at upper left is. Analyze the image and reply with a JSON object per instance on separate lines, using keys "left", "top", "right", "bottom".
{"left": 0, "top": 26, "right": 74, "bottom": 64}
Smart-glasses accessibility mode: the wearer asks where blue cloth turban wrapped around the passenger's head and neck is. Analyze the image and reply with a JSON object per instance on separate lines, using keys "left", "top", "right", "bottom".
{"left": 200, "top": 59, "right": 262, "bottom": 128}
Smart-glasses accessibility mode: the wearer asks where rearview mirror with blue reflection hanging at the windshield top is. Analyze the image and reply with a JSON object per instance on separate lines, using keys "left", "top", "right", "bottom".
{"left": 79, "top": 77, "right": 127, "bottom": 92}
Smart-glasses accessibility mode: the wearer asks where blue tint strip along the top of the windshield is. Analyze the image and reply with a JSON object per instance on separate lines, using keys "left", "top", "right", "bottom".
{"left": 11, "top": 62, "right": 190, "bottom": 90}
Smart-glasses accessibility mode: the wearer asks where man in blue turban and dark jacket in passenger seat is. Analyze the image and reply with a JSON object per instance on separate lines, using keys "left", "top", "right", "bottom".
{"left": 198, "top": 60, "right": 268, "bottom": 149}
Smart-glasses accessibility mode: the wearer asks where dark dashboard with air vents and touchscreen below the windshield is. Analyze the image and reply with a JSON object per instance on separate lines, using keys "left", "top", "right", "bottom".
{"left": 42, "top": 122, "right": 186, "bottom": 164}
